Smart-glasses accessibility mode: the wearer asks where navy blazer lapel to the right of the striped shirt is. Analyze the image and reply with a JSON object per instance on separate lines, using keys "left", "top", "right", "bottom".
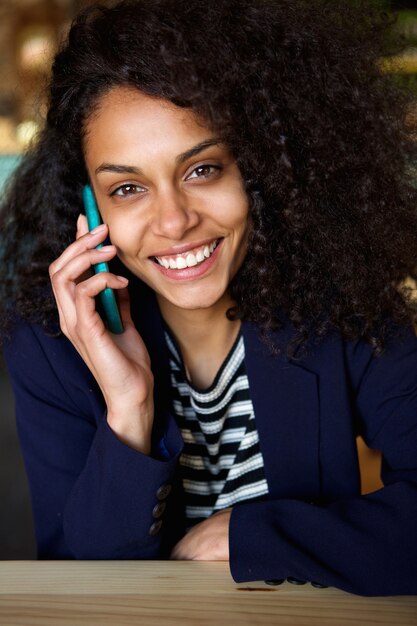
{"left": 242, "top": 323, "right": 320, "bottom": 500}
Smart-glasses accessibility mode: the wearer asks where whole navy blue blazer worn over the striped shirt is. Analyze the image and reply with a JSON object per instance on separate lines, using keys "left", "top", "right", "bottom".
{"left": 5, "top": 282, "right": 417, "bottom": 595}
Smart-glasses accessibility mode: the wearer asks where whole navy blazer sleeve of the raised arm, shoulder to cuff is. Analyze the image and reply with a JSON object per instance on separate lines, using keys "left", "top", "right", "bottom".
{"left": 4, "top": 325, "right": 181, "bottom": 559}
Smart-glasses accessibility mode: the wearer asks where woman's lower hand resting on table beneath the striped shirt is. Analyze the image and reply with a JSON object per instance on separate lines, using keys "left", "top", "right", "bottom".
{"left": 171, "top": 509, "right": 232, "bottom": 561}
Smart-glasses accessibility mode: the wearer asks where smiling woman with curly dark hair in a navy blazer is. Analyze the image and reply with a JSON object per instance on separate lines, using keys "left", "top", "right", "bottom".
{"left": 1, "top": 0, "right": 417, "bottom": 595}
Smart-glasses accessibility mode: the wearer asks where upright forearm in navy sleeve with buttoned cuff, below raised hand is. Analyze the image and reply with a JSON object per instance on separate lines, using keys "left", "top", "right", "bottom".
{"left": 63, "top": 414, "right": 180, "bottom": 559}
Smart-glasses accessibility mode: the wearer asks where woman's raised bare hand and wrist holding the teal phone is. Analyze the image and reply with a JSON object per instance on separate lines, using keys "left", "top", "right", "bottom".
{"left": 49, "top": 216, "right": 153, "bottom": 454}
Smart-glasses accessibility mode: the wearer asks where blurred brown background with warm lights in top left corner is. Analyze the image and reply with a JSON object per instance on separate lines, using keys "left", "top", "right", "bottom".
{"left": 0, "top": 0, "right": 93, "bottom": 161}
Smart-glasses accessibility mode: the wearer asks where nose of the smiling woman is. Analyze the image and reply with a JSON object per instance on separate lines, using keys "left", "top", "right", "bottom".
{"left": 153, "top": 188, "right": 200, "bottom": 240}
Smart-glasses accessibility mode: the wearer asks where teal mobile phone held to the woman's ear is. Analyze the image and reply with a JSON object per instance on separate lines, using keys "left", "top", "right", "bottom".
{"left": 83, "top": 185, "right": 124, "bottom": 335}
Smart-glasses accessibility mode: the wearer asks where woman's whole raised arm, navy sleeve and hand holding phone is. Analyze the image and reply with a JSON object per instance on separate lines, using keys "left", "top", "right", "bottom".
{"left": 3, "top": 216, "right": 184, "bottom": 558}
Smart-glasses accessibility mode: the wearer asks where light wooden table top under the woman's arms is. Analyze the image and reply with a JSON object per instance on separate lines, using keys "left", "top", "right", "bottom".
{"left": 0, "top": 561, "right": 417, "bottom": 626}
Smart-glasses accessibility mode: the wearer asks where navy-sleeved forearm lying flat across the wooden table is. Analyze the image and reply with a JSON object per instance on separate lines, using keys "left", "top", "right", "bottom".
{"left": 229, "top": 482, "right": 417, "bottom": 595}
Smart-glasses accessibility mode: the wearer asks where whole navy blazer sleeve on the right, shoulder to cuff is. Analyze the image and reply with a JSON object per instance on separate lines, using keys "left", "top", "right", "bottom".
{"left": 229, "top": 331, "right": 417, "bottom": 595}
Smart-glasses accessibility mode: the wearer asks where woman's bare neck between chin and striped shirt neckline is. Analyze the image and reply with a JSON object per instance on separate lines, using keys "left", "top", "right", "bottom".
{"left": 157, "top": 296, "right": 240, "bottom": 389}
